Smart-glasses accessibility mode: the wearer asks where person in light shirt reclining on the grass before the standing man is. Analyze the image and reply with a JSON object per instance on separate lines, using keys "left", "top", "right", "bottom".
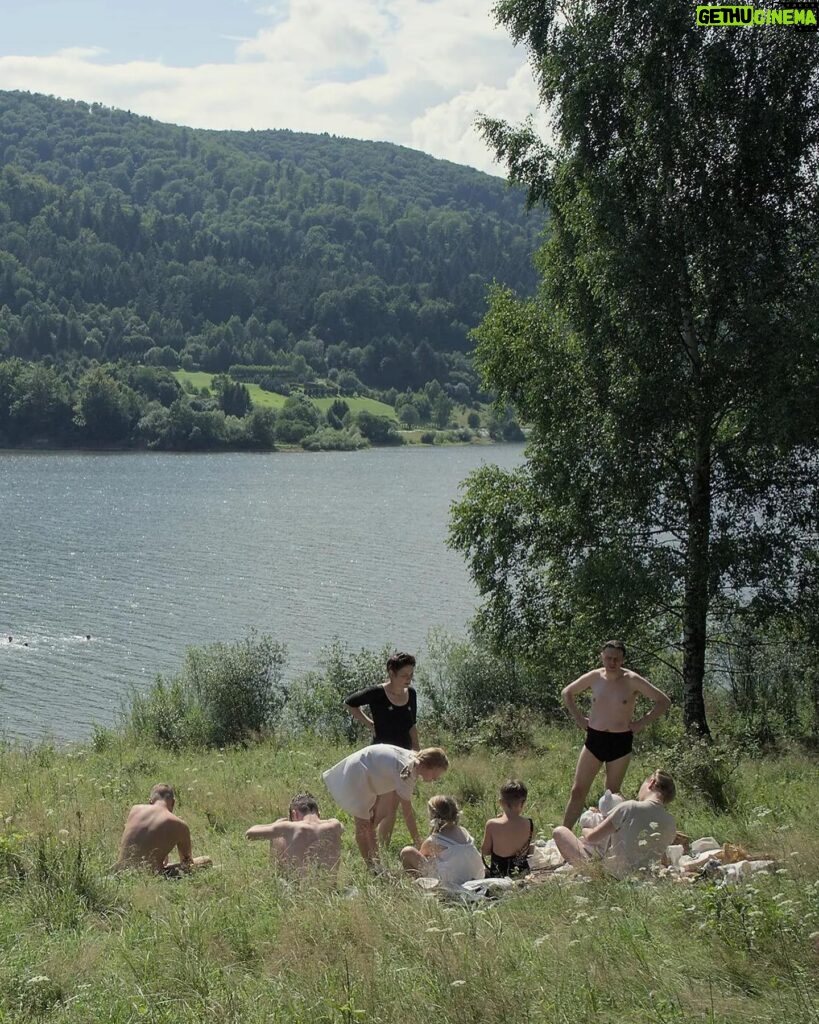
{"left": 553, "top": 771, "right": 677, "bottom": 878}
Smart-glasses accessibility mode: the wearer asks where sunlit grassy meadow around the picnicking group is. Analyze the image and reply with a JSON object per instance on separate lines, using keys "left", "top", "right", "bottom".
{"left": 0, "top": 728, "right": 819, "bottom": 1024}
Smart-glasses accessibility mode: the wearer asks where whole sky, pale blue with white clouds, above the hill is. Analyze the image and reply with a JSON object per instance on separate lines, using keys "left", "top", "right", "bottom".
{"left": 0, "top": 0, "right": 541, "bottom": 174}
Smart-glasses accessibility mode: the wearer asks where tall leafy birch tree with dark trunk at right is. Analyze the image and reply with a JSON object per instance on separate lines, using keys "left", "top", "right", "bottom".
{"left": 451, "top": 0, "right": 819, "bottom": 730}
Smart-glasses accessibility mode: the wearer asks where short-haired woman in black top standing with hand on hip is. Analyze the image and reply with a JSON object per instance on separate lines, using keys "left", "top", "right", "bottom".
{"left": 344, "top": 651, "right": 421, "bottom": 844}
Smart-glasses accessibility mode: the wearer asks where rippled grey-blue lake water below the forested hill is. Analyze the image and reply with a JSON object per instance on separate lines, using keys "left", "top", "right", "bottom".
{"left": 0, "top": 445, "right": 523, "bottom": 739}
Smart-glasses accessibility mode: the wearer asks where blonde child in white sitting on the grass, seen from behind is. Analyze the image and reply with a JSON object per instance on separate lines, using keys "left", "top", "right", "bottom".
{"left": 401, "top": 795, "right": 486, "bottom": 886}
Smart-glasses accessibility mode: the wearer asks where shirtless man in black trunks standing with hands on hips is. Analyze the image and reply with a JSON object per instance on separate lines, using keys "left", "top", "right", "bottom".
{"left": 562, "top": 640, "right": 671, "bottom": 828}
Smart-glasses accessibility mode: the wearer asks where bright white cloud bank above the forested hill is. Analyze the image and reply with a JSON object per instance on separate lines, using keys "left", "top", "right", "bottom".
{"left": 0, "top": 0, "right": 536, "bottom": 174}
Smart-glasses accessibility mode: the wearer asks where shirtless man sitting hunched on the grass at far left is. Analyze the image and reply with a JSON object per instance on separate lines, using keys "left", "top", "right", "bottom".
{"left": 115, "top": 782, "right": 211, "bottom": 878}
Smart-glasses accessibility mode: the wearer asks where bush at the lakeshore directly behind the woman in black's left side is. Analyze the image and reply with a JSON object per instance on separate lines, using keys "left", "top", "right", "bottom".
{"left": 285, "top": 639, "right": 392, "bottom": 743}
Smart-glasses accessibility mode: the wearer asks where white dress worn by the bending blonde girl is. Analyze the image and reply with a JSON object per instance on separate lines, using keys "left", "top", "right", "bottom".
{"left": 321, "top": 743, "right": 416, "bottom": 818}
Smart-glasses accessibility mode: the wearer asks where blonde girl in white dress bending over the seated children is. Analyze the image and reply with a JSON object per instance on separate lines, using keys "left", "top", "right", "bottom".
{"left": 321, "top": 743, "right": 449, "bottom": 865}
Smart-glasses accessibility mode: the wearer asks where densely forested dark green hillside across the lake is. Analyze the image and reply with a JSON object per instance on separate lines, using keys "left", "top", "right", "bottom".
{"left": 0, "top": 92, "right": 543, "bottom": 442}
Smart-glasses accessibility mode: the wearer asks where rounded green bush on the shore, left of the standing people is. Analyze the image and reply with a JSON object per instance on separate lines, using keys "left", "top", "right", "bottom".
{"left": 126, "top": 634, "right": 287, "bottom": 749}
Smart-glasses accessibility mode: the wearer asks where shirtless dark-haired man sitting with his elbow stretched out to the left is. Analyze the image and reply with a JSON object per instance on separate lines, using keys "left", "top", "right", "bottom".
{"left": 245, "top": 793, "right": 344, "bottom": 873}
